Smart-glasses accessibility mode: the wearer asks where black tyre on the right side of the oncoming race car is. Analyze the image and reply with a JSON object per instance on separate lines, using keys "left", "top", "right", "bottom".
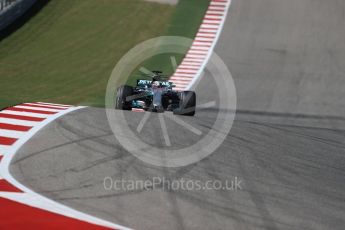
{"left": 174, "top": 91, "right": 196, "bottom": 116}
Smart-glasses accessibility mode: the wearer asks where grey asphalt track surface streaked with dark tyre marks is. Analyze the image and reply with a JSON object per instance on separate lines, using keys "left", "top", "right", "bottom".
{"left": 11, "top": 0, "right": 345, "bottom": 229}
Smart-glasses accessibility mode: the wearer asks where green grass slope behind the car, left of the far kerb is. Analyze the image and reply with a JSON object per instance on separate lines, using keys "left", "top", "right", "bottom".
{"left": 0, "top": 0, "right": 209, "bottom": 108}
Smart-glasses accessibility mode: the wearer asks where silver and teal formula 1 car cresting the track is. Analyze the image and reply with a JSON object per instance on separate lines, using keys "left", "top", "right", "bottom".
{"left": 116, "top": 71, "right": 196, "bottom": 116}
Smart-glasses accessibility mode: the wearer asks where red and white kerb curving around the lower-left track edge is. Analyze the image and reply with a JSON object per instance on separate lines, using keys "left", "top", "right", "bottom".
{"left": 0, "top": 102, "right": 126, "bottom": 229}
